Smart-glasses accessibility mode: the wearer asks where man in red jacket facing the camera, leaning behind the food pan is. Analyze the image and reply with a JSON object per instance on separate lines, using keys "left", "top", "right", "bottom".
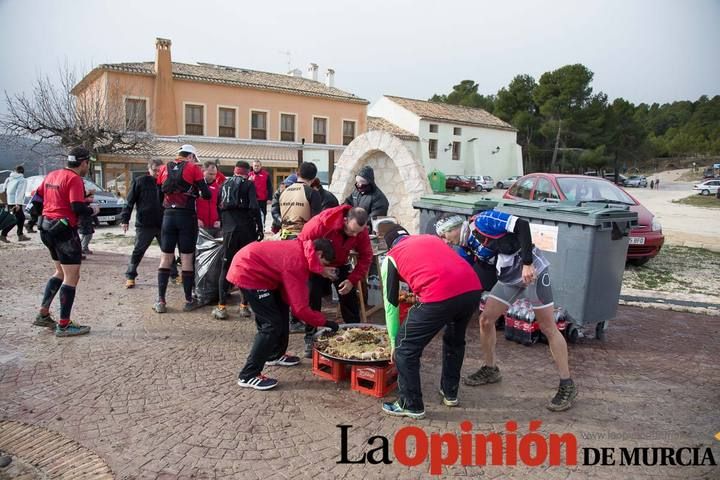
{"left": 298, "top": 205, "right": 373, "bottom": 358}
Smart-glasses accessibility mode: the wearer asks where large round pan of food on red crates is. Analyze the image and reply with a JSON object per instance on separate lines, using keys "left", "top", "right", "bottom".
{"left": 314, "top": 323, "right": 390, "bottom": 365}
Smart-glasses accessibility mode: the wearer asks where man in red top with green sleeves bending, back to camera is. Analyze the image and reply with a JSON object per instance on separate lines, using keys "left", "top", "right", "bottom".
{"left": 382, "top": 225, "right": 482, "bottom": 419}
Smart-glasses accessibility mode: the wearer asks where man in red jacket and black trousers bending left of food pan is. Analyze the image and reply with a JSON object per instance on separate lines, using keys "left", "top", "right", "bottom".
{"left": 227, "top": 239, "right": 338, "bottom": 390}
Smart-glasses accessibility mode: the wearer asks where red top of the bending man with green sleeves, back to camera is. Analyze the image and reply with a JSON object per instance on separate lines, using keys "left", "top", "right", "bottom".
{"left": 383, "top": 235, "right": 482, "bottom": 303}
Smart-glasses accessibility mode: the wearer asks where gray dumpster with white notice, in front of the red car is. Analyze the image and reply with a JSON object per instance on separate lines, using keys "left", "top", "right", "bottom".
{"left": 495, "top": 200, "right": 637, "bottom": 341}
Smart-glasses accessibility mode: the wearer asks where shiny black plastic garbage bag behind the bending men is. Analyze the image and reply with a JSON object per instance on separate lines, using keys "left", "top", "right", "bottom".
{"left": 195, "top": 228, "right": 225, "bottom": 305}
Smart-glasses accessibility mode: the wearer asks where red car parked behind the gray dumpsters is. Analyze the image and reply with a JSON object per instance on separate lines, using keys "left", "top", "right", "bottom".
{"left": 503, "top": 173, "right": 665, "bottom": 266}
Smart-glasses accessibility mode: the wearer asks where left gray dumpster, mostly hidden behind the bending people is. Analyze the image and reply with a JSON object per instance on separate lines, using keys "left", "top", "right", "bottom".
{"left": 413, "top": 194, "right": 498, "bottom": 235}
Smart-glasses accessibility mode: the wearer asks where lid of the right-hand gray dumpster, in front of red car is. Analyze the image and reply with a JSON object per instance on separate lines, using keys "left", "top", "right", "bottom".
{"left": 496, "top": 200, "right": 637, "bottom": 225}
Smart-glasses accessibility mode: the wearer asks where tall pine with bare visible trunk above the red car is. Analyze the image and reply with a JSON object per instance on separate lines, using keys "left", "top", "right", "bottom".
{"left": 534, "top": 64, "right": 593, "bottom": 170}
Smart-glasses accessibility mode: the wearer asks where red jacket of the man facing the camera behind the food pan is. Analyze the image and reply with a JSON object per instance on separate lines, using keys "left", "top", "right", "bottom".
{"left": 298, "top": 205, "right": 373, "bottom": 285}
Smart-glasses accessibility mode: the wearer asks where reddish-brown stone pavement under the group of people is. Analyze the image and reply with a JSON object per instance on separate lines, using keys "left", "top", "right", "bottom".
{"left": 0, "top": 246, "right": 720, "bottom": 480}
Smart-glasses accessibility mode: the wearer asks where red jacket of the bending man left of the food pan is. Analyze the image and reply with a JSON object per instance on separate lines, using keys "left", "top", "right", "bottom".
{"left": 227, "top": 239, "right": 328, "bottom": 327}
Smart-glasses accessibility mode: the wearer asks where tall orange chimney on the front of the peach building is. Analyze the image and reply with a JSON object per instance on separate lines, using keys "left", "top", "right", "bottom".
{"left": 152, "top": 38, "right": 178, "bottom": 135}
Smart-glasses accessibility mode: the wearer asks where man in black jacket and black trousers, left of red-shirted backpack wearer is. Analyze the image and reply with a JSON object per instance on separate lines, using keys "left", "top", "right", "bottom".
{"left": 122, "top": 159, "right": 178, "bottom": 288}
